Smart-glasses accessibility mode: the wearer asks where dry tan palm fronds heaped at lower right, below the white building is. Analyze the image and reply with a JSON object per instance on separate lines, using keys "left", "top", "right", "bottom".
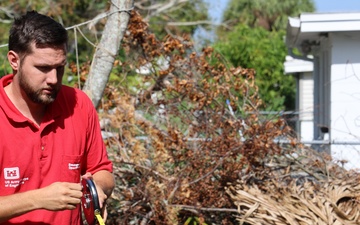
{"left": 226, "top": 147, "right": 360, "bottom": 225}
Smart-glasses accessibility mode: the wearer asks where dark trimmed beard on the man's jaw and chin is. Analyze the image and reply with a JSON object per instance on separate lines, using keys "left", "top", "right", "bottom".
{"left": 18, "top": 69, "right": 60, "bottom": 105}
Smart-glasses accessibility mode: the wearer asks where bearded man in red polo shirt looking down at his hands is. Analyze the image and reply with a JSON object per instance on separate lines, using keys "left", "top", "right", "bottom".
{"left": 0, "top": 11, "right": 114, "bottom": 225}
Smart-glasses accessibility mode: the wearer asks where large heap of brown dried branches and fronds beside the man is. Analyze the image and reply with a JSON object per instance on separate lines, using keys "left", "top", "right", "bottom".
{"left": 90, "top": 12, "right": 359, "bottom": 224}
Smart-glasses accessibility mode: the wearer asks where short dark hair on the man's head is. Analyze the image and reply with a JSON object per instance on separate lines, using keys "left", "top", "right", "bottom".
{"left": 9, "top": 11, "right": 68, "bottom": 56}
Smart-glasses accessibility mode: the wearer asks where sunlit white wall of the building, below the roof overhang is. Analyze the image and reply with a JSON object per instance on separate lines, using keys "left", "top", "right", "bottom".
{"left": 330, "top": 32, "right": 360, "bottom": 169}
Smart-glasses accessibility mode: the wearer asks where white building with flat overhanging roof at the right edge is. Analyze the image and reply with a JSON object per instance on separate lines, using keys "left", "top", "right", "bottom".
{"left": 285, "top": 12, "right": 360, "bottom": 169}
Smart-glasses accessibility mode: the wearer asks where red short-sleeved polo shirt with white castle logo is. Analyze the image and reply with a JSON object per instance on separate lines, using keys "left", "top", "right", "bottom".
{"left": 0, "top": 75, "right": 112, "bottom": 225}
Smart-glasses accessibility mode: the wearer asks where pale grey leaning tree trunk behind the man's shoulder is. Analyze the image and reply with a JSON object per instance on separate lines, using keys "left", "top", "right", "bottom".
{"left": 83, "top": 0, "right": 134, "bottom": 107}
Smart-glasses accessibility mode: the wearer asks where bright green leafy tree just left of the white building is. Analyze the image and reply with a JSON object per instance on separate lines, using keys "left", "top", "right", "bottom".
{"left": 214, "top": 24, "right": 295, "bottom": 110}
